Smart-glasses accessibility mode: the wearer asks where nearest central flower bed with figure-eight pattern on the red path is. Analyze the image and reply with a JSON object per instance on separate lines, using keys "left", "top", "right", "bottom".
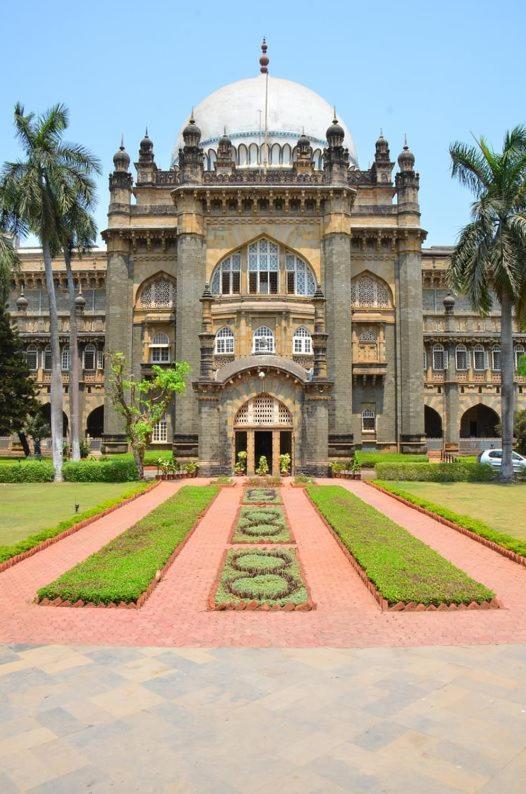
{"left": 215, "top": 548, "right": 308, "bottom": 606}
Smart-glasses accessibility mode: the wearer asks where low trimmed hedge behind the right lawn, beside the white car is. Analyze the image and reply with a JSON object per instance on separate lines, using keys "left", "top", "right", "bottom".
{"left": 375, "top": 462, "right": 497, "bottom": 482}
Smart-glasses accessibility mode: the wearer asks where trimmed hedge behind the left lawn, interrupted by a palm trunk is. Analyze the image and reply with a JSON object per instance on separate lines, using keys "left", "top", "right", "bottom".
{"left": 0, "top": 460, "right": 138, "bottom": 482}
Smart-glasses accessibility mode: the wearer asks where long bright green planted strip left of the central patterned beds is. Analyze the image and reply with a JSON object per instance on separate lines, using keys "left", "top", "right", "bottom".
{"left": 38, "top": 485, "right": 219, "bottom": 604}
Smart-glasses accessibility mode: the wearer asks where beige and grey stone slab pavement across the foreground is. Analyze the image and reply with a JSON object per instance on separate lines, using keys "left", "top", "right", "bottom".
{"left": 0, "top": 645, "right": 526, "bottom": 794}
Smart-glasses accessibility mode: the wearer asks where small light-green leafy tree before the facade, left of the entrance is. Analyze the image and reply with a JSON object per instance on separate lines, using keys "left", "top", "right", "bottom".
{"left": 109, "top": 353, "right": 190, "bottom": 479}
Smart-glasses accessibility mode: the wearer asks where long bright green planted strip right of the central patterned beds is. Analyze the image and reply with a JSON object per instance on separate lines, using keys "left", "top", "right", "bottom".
{"left": 307, "top": 485, "right": 494, "bottom": 606}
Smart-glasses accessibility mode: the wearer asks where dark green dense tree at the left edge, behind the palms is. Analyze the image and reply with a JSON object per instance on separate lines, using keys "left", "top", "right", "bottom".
{"left": 0, "top": 303, "right": 37, "bottom": 442}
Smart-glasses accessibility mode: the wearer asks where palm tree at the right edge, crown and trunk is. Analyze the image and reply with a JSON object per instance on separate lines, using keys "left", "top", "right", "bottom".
{"left": 450, "top": 126, "right": 526, "bottom": 483}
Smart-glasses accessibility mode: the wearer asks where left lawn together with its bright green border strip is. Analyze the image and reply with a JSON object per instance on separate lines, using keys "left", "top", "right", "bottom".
{"left": 0, "top": 482, "right": 150, "bottom": 562}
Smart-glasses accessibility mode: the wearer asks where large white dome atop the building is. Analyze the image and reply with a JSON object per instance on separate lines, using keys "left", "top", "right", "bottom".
{"left": 173, "top": 74, "right": 356, "bottom": 164}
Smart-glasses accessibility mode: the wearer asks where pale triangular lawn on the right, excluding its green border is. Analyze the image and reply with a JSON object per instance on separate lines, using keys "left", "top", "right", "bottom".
{"left": 379, "top": 481, "right": 526, "bottom": 540}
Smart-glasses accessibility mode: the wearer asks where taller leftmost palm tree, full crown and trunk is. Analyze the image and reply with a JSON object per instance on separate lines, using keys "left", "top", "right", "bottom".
{"left": 0, "top": 104, "right": 99, "bottom": 481}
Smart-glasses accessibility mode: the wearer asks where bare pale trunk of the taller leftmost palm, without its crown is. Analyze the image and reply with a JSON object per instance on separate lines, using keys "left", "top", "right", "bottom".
{"left": 42, "top": 240, "right": 64, "bottom": 482}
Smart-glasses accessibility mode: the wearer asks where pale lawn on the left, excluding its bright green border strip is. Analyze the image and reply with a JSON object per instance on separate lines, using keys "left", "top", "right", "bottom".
{"left": 0, "top": 482, "right": 147, "bottom": 548}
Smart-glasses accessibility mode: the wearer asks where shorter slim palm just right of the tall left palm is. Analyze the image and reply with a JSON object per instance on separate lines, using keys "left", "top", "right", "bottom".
{"left": 63, "top": 207, "right": 99, "bottom": 460}
